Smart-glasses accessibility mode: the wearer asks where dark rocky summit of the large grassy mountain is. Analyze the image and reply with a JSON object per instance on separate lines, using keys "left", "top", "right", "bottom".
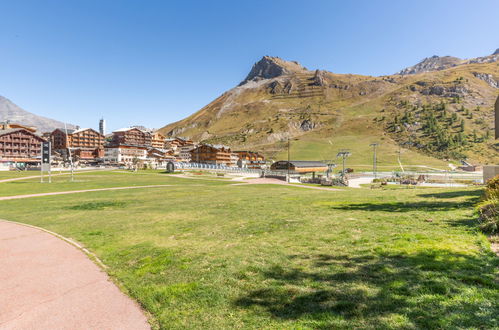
{"left": 240, "top": 56, "right": 307, "bottom": 85}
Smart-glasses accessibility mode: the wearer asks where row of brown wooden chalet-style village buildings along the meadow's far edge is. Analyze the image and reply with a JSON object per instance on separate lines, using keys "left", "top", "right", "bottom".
{"left": 0, "top": 120, "right": 265, "bottom": 169}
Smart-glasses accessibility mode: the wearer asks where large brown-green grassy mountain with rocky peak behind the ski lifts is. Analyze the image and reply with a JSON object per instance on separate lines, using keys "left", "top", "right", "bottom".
{"left": 161, "top": 54, "right": 499, "bottom": 168}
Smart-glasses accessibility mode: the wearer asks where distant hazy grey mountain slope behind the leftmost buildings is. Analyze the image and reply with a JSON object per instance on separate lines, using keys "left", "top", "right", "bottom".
{"left": 0, "top": 95, "right": 74, "bottom": 132}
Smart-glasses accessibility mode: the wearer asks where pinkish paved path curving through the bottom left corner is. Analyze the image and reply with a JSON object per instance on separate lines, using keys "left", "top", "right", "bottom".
{"left": 0, "top": 221, "right": 150, "bottom": 330}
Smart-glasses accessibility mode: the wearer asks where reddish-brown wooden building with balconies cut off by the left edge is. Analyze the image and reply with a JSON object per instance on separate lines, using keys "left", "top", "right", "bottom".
{"left": 0, "top": 128, "right": 45, "bottom": 164}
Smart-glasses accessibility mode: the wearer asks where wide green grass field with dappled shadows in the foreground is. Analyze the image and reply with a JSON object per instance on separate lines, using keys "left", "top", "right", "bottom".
{"left": 0, "top": 171, "right": 499, "bottom": 329}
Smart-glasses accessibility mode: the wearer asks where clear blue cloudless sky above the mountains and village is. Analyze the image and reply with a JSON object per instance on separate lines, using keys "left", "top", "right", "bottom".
{"left": 0, "top": 0, "right": 499, "bottom": 131}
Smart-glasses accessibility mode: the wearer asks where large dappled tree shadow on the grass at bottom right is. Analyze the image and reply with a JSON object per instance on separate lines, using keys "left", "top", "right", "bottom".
{"left": 235, "top": 250, "right": 499, "bottom": 329}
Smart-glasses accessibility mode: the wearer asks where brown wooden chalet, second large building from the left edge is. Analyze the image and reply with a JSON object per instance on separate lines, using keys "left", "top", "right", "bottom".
{"left": 50, "top": 128, "right": 104, "bottom": 161}
